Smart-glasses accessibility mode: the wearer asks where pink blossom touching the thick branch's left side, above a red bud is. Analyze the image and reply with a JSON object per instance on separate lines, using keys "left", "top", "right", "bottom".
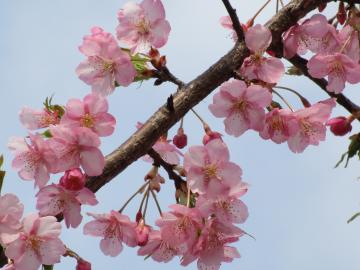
{"left": 49, "top": 125, "right": 105, "bottom": 176}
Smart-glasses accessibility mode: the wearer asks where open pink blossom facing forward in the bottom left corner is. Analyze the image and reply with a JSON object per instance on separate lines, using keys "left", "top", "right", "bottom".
{"left": 5, "top": 214, "right": 66, "bottom": 270}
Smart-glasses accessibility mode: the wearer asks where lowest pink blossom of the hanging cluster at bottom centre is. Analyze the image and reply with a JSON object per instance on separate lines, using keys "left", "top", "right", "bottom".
{"left": 181, "top": 219, "right": 244, "bottom": 270}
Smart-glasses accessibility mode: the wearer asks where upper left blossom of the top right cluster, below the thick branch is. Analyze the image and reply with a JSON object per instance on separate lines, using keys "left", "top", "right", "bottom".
{"left": 283, "top": 14, "right": 339, "bottom": 58}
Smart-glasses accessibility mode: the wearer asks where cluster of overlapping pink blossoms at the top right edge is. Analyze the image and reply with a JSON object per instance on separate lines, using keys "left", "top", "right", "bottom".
{"left": 283, "top": 14, "right": 360, "bottom": 94}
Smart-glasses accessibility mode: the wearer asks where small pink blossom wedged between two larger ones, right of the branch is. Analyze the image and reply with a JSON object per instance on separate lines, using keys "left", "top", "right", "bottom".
{"left": 260, "top": 108, "right": 299, "bottom": 143}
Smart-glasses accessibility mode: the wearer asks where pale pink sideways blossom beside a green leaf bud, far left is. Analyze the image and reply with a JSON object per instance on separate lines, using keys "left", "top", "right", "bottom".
{"left": 19, "top": 107, "right": 60, "bottom": 130}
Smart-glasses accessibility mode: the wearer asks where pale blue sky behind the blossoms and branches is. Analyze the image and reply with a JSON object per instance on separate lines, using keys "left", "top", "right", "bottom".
{"left": 0, "top": 0, "right": 360, "bottom": 270}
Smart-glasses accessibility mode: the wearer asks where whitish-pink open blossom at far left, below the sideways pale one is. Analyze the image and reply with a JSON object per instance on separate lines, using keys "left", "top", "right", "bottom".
{"left": 8, "top": 133, "right": 55, "bottom": 187}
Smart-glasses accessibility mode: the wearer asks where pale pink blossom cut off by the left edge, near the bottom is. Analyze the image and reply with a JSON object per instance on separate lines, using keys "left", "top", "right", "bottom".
{"left": 0, "top": 194, "right": 24, "bottom": 245}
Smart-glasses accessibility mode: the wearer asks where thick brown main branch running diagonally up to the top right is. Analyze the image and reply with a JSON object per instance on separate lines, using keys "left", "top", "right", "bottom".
{"left": 87, "top": 0, "right": 360, "bottom": 192}
